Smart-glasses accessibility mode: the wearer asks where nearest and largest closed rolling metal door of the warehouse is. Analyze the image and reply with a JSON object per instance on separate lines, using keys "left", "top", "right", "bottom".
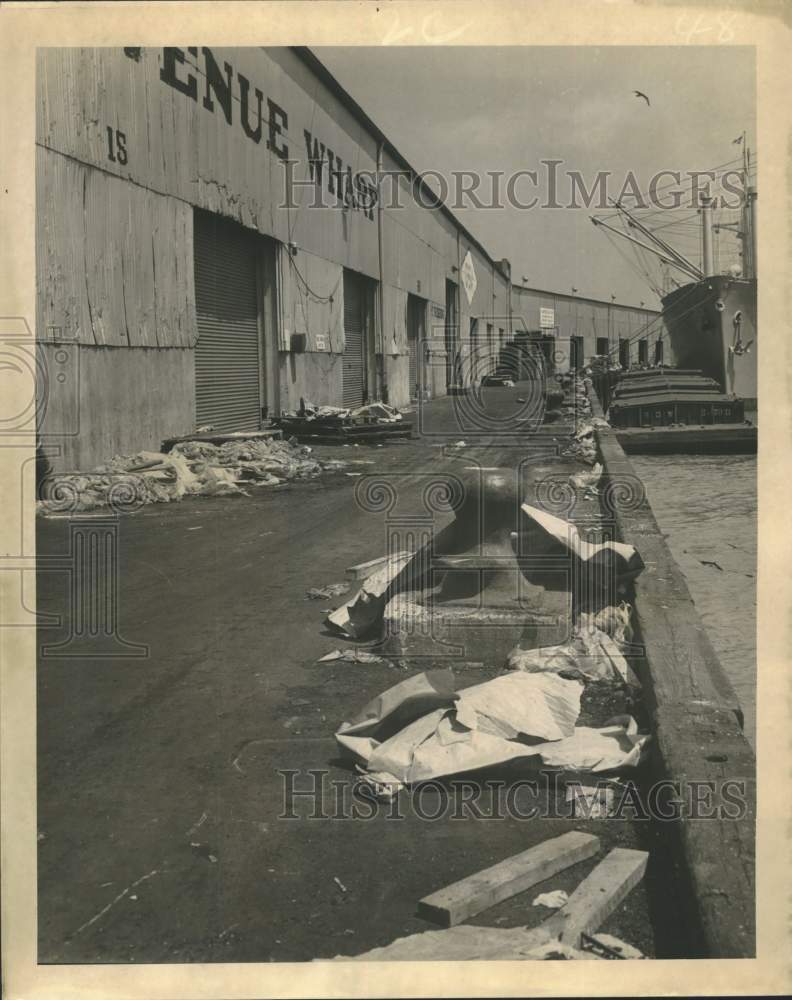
{"left": 195, "top": 212, "right": 261, "bottom": 431}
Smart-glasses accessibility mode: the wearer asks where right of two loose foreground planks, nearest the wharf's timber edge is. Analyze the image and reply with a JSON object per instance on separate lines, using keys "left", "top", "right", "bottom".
{"left": 540, "top": 847, "right": 649, "bottom": 948}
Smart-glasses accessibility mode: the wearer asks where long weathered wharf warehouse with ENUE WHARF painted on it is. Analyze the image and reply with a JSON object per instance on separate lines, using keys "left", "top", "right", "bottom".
{"left": 36, "top": 47, "right": 660, "bottom": 469}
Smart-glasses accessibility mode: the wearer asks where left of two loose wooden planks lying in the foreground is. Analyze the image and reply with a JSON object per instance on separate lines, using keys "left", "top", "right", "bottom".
{"left": 418, "top": 830, "right": 600, "bottom": 927}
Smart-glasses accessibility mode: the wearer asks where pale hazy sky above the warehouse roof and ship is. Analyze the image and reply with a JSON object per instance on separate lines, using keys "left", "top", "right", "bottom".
{"left": 314, "top": 46, "right": 756, "bottom": 307}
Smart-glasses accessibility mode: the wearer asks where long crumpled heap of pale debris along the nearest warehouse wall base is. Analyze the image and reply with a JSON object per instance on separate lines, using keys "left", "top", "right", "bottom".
{"left": 37, "top": 438, "right": 328, "bottom": 514}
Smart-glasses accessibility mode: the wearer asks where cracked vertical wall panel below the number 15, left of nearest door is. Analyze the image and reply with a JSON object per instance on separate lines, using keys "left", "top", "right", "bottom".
{"left": 36, "top": 148, "right": 196, "bottom": 347}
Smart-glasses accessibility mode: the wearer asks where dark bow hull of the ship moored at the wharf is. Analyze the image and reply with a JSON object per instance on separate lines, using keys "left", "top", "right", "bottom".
{"left": 663, "top": 275, "right": 758, "bottom": 411}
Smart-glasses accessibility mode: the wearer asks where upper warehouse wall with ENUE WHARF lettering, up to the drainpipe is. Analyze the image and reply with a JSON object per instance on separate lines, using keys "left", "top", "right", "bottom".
{"left": 37, "top": 48, "right": 379, "bottom": 278}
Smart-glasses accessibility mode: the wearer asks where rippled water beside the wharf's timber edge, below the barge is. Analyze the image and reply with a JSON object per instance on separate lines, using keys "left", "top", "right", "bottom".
{"left": 630, "top": 455, "right": 756, "bottom": 746}
